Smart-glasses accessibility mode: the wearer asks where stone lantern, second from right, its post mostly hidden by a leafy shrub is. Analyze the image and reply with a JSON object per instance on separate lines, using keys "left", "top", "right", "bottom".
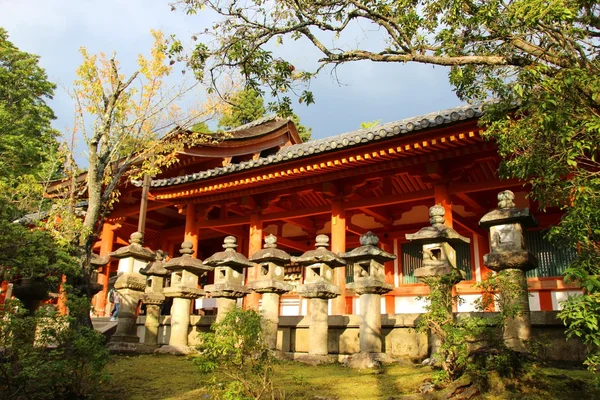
{"left": 406, "top": 205, "right": 471, "bottom": 357}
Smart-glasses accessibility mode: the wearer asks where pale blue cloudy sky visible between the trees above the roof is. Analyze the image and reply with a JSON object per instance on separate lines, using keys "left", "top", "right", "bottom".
{"left": 0, "top": 0, "right": 460, "bottom": 158}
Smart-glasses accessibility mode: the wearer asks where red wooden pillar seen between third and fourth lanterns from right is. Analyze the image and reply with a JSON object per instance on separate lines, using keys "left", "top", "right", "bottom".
{"left": 331, "top": 199, "right": 352, "bottom": 315}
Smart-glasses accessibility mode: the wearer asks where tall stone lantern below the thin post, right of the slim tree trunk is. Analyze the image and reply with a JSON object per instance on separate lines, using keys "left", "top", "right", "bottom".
{"left": 109, "top": 232, "right": 155, "bottom": 351}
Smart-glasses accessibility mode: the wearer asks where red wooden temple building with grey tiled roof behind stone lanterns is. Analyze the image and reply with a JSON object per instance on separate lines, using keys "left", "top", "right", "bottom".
{"left": 84, "top": 106, "right": 579, "bottom": 317}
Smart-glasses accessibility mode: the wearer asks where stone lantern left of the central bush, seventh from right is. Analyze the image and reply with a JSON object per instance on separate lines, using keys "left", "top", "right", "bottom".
{"left": 161, "top": 241, "right": 213, "bottom": 353}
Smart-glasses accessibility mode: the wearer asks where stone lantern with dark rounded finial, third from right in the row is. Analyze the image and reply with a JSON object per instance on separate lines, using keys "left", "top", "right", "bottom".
{"left": 340, "top": 232, "right": 396, "bottom": 366}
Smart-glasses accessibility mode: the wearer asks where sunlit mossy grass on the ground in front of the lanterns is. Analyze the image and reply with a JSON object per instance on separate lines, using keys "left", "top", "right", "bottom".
{"left": 101, "top": 355, "right": 600, "bottom": 400}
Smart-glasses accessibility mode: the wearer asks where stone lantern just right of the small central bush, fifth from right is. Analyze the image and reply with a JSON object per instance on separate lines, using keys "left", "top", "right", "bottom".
{"left": 248, "top": 235, "right": 292, "bottom": 350}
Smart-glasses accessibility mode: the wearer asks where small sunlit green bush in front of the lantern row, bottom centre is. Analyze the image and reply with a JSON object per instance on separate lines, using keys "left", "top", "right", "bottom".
{"left": 196, "top": 308, "right": 282, "bottom": 400}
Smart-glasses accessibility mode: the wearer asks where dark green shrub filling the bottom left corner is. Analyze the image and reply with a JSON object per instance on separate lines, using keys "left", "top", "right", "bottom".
{"left": 0, "top": 301, "right": 108, "bottom": 400}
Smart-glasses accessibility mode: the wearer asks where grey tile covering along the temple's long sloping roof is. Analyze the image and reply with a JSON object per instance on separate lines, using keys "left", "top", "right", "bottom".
{"left": 138, "top": 105, "right": 483, "bottom": 188}
